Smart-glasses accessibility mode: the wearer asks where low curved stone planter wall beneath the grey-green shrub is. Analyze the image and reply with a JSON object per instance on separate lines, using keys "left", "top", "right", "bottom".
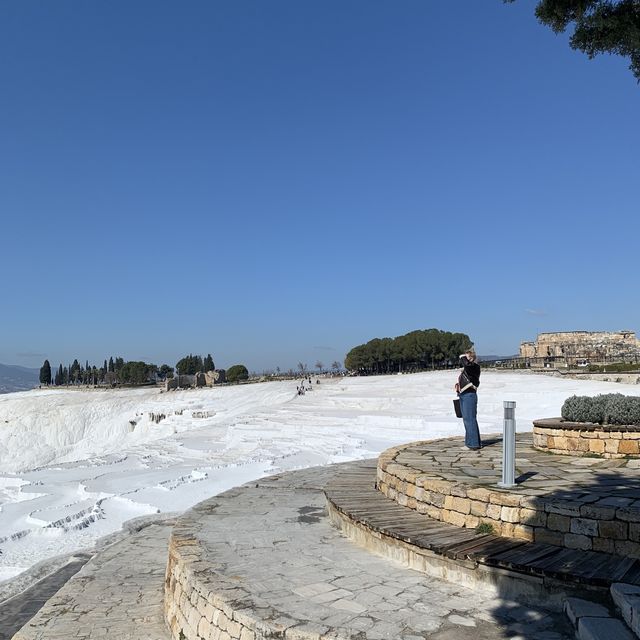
{"left": 533, "top": 418, "right": 640, "bottom": 458}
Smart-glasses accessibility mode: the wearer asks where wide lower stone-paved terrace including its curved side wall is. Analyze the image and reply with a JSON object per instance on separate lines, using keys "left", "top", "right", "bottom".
{"left": 167, "top": 465, "right": 571, "bottom": 640}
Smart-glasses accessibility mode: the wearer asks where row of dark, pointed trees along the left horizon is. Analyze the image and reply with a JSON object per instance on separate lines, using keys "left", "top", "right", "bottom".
{"left": 40, "top": 354, "right": 220, "bottom": 386}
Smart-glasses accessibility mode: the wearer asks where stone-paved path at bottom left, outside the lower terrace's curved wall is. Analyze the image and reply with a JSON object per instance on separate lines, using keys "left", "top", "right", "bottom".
{"left": 13, "top": 520, "right": 173, "bottom": 640}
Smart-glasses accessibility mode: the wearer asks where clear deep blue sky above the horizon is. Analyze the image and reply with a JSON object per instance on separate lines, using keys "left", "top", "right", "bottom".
{"left": 0, "top": 0, "right": 640, "bottom": 371}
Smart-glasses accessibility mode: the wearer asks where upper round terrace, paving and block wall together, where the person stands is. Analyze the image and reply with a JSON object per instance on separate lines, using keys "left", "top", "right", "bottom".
{"left": 378, "top": 433, "right": 640, "bottom": 558}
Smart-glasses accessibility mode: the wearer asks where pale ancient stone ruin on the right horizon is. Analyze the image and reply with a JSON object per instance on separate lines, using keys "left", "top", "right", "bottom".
{"left": 520, "top": 331, "right": 640, "bottom": 364}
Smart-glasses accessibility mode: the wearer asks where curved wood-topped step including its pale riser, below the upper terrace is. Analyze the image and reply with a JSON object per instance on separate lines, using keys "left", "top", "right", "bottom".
{"left": 325, "top": 460, "right": 640, "bottom": 609}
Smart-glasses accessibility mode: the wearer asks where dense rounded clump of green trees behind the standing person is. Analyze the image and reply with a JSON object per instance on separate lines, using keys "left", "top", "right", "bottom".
{"left": 344, "top": 329, "right": 473, "bottom": 375}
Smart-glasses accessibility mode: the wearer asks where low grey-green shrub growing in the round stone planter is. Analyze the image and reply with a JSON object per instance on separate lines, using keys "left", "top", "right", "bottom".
{"left": 561, "top": 393, "right": 640, "bottom": 426}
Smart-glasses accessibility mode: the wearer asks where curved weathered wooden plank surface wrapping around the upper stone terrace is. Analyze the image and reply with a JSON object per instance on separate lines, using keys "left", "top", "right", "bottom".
{"left": 325, "top": 461, "right": 640, "bottom": 588}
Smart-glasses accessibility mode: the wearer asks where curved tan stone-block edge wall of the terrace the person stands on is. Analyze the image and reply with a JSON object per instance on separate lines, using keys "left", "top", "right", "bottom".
{"left": 376, "top": 441, "right": 640, "bottom": 558}
